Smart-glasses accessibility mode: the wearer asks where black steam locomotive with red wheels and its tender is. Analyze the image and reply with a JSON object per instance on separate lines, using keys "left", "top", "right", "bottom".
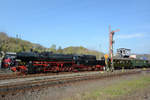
{"left": 3, "top": 52, "right": 105, "bottom": 73}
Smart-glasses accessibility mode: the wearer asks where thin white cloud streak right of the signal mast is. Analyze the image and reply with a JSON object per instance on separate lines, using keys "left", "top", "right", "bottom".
{"left": 116, "top": 33, "right": 145, "bottom": 39}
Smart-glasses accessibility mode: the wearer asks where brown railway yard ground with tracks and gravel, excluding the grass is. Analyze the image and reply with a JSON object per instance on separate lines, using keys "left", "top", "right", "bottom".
{"left": 0, "top": 68, "right": 150, "bottom": 100}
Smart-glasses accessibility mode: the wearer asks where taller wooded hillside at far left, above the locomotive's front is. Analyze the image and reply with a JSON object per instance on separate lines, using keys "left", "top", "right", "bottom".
{"left": 0, "top": 32, "right": 45, "bottom": 52}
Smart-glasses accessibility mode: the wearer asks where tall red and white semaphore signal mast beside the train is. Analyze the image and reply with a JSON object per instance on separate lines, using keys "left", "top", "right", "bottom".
{"left": 109, "top": 26, "right": 120, "bottom": 71}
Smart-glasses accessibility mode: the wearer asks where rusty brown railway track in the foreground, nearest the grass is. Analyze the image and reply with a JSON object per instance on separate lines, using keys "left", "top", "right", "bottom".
{"left": 0, "top": 69, "right": 146, "bottom": 95}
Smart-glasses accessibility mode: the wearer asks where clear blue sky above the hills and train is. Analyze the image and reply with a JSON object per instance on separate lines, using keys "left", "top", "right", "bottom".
{"left": 0, "top": 0, "right": 150, "bottom": 53}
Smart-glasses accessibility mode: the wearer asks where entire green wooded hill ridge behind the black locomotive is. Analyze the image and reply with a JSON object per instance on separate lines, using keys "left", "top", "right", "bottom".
{"left": 0, "top": 32, "right": 104, "bottom": 58}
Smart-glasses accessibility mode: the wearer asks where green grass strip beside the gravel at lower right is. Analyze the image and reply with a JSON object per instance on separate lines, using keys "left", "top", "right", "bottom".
{"left": 66, "top": 75, "right": 150, "bottom": 100}
